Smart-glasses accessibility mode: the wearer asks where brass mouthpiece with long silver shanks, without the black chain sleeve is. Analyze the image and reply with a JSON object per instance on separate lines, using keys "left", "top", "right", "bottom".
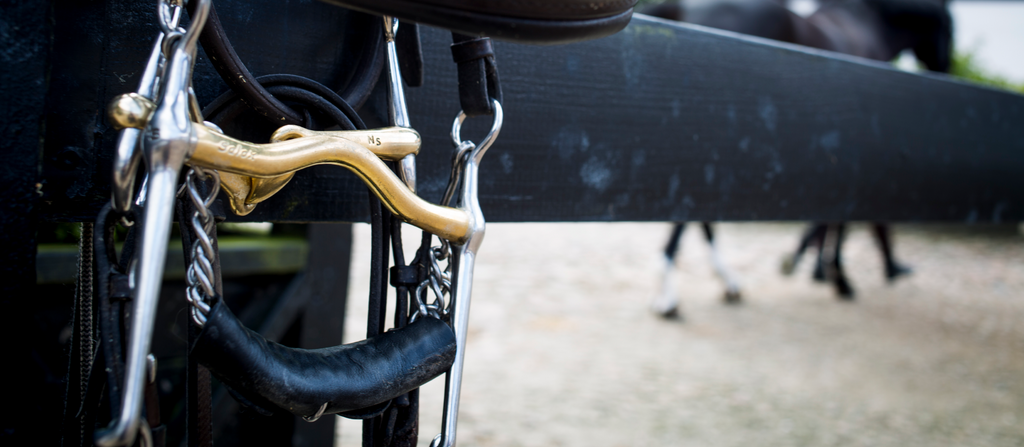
{"left": 96, "top": 0, "right": 503, "bottom": 446}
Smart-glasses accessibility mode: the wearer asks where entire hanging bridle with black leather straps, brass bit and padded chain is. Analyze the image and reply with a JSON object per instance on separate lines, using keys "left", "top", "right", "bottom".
{"left": 66, "top": 0, "right": 636, "bottom": 441}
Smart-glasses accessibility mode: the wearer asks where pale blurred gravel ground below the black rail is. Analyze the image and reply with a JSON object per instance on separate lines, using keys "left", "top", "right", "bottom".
{"left": 339, "top": 223, "right": 1024, "bottom": 447}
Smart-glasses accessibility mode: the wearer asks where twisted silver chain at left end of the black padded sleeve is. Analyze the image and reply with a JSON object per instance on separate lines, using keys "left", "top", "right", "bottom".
{"left": 179, "top": 167, "right": 220, "bottom": 327}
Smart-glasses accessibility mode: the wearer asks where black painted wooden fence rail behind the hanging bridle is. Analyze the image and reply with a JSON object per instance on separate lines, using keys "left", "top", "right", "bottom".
{"left": 29, "top": 5, "right": 1024, "bottom": 222}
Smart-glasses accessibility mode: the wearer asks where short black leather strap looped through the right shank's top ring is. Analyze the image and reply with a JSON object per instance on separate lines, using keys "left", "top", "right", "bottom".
{"left": 452, "top": 33, "right": 502, "bottom": 117}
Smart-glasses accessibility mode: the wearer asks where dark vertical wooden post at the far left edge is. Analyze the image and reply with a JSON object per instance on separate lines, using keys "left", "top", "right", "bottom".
{"left": 0, "top": 0, "right": 49, "bottom": 439}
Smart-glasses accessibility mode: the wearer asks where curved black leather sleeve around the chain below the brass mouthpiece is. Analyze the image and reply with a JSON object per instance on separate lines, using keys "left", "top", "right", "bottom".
{"left": 189, "top": 301, "right": 456, "bottom": 416}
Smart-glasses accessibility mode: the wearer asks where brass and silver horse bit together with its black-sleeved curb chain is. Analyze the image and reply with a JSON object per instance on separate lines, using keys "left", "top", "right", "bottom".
{"left": 96, "top": 0, "right": 503, "bottom": 446}
